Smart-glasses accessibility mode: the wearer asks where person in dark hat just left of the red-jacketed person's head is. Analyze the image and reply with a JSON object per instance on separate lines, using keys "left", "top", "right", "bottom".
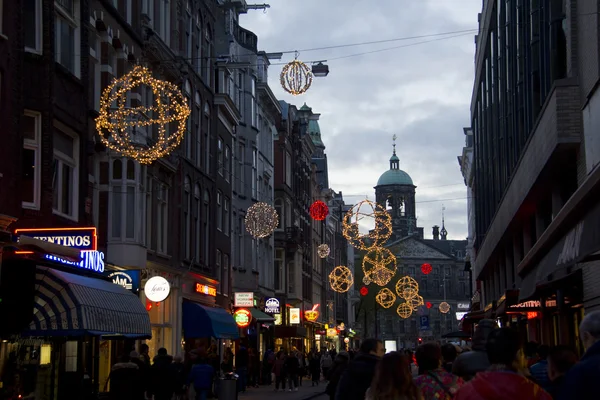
{"left": 452, "top": 319, "right": 498, "bottom": 381}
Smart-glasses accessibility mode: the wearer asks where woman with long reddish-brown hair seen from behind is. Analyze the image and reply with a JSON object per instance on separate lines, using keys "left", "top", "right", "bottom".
{"left": 365, "top": 351, "right": 422, "bottom": 400}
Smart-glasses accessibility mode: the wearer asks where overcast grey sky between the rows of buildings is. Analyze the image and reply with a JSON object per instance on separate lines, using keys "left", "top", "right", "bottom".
{"left": 240, "top": 0, "right": 481, "bottom": 239}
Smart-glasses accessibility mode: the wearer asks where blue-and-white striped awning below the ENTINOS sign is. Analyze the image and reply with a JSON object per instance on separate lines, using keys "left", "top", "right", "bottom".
{"left": 23, "top": 266, "right": 152, "bottom": 339}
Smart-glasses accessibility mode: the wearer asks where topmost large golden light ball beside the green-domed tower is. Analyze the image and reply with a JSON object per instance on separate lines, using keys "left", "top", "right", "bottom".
{"left": 342, "top": 200, "right": 392, "bottom": 250}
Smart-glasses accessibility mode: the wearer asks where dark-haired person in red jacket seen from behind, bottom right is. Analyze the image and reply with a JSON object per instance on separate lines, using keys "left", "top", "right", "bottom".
{"left": 454, "top": 328, "right": 552, "bottom": 400}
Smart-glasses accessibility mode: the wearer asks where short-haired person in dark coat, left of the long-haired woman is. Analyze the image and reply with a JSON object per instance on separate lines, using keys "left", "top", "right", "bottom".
{"left": 335, "top": 339, "right": 385, "bottom": 400}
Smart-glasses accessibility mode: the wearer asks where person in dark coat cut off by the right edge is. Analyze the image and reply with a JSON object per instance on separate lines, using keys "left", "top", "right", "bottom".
{"left": 558, "top": 311, "right": 600, "bottom": 400}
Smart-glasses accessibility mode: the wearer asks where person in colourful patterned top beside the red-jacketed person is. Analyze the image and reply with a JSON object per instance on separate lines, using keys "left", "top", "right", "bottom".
{"left": 415, "top": 342, "right": 465, "bottom": 400}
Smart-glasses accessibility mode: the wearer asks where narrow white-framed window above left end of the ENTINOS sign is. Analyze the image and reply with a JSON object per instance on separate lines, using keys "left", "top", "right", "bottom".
{"left": 21, "top": 110, "right": 42, "bottom": 210}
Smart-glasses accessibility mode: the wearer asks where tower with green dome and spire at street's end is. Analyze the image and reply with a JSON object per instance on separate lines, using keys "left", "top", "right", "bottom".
{"left": 375, "top": 135, "right": 423, "bottom": 240}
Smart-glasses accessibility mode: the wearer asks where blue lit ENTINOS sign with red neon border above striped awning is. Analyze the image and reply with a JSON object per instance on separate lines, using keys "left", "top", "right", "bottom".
{"left": 15, "top": 227, "right": 104, "bottom": 274}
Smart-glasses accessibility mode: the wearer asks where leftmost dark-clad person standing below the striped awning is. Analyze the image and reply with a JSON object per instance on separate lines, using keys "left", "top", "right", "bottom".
{"left": 108, "top": 355, "right": 144, "bottom": 400}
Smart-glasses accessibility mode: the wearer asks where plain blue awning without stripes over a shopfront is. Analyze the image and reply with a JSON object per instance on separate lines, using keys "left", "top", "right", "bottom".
{"left": 182, "top": 301, "right": 240, "bottom": 339}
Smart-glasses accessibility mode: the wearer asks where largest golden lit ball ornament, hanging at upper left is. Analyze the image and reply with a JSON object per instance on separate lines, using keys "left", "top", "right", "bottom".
{"left": 96, "top": 65, "right": 190, "bottom": 164}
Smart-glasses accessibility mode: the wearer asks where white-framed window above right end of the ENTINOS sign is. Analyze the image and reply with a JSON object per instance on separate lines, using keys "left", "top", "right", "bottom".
{"left": 52, "top": 123, "right": 79, "bottom": 220}
